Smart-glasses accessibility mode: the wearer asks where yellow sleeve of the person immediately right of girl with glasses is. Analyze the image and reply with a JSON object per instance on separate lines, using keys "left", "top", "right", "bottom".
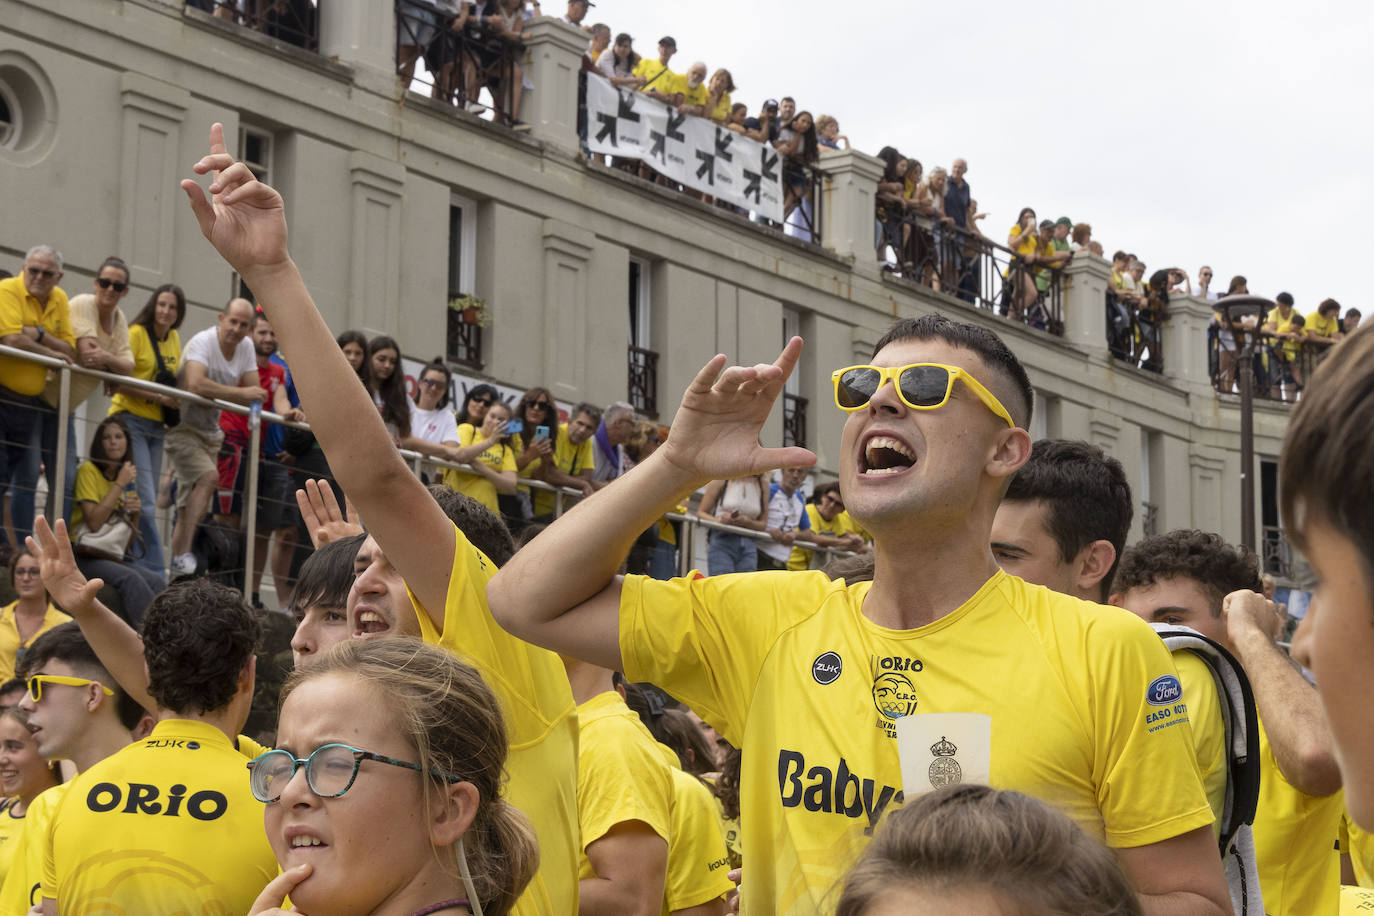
{"left": 577, "top": 717, "right": 672, "bottom": 853}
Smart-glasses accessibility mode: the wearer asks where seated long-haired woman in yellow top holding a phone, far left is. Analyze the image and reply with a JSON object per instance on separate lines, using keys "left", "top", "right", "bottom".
{"left": 70, "top": 416, "right": 165, "bottom": 629}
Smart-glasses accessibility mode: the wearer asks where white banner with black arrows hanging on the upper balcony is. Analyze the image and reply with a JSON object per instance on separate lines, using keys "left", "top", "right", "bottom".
{"left": 587, "top": 73, "right": 782, "bottom": 222}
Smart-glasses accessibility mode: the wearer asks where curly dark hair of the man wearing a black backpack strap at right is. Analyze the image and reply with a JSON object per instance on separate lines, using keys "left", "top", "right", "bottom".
{"left": 1112, "top": 527, "right": 1264, "bottom": 617}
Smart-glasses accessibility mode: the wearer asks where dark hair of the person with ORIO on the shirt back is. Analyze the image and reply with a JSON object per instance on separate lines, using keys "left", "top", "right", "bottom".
{"left": 143, "top": 578, "right": 262, "bottom": 714}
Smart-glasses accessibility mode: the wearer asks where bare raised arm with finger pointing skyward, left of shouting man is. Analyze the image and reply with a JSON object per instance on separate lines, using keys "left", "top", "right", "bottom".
{"left": 181, "top": 124, "right": 453, "bottom": 626}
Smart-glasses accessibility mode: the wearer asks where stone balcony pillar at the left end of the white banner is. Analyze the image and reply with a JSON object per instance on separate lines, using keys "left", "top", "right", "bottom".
{"left": 521, "top": 16, "right": 588, "bottom": 154}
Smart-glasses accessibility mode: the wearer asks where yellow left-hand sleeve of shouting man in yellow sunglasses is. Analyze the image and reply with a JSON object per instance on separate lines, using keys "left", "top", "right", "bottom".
{"left": 620, "top": 571, "right": 835, "bottom": 747}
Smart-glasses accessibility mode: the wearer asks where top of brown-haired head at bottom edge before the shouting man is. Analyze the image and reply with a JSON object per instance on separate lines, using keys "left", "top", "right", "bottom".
{"left": 835, "top": 786, "right": 1142, "bottom": 916}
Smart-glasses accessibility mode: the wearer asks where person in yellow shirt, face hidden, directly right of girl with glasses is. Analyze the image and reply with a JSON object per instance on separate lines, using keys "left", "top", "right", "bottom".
{"left": 563, "top": 658, "right": 673, "bottom": 913}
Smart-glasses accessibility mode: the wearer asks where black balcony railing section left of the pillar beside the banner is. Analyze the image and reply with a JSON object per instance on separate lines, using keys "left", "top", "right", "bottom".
{"left": 396, "top": 0, "right": 525, "bottom": 125}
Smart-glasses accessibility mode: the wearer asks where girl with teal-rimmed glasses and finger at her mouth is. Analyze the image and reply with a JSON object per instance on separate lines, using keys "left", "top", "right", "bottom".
{"left": 249, "top": 637, "right": 539, "bottom": 916}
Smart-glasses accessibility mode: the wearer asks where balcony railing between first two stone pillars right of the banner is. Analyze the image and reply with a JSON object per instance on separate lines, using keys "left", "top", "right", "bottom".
{"left": 877, "top": 218, "right": 1063, "bottom": 336}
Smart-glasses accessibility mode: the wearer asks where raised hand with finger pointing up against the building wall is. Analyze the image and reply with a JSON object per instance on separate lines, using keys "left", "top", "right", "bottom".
{"left": 181, "top": 124, "right": 290, "bottom": 276}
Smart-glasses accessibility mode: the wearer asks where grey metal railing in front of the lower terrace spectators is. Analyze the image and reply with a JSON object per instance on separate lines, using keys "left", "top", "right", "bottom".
{"left": 0, "top": 345, "right": 849, "bottom": 602}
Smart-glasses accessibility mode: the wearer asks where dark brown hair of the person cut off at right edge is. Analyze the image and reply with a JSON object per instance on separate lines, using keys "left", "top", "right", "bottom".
{"left": 1279, "top": 327, "right": 1374, "bottom": 589}
